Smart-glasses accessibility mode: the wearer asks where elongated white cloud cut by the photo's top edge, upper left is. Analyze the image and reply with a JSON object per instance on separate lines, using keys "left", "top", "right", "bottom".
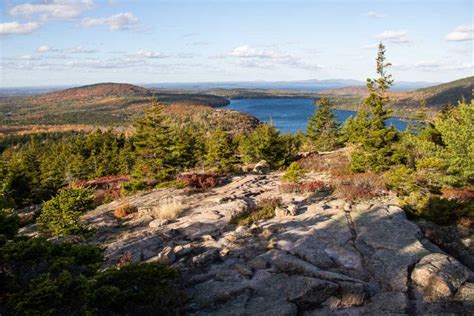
{"left": 8, "top": 0, "right": 93, "bottom": 20}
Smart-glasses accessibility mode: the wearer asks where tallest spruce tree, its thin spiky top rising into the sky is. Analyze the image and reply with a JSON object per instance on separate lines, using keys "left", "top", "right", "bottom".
{"left": 351, "top": 43, "right": 400, "bottom": 172}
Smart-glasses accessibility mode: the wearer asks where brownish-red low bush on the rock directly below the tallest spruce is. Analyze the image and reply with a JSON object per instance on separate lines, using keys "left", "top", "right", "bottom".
{"left": 331, "top": 172, "right": 385, "bottom": 201}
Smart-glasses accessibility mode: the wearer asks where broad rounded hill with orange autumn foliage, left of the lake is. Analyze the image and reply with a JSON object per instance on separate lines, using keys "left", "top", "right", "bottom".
{"left": 0, "top": 83, "right": 229, "bottom": 125}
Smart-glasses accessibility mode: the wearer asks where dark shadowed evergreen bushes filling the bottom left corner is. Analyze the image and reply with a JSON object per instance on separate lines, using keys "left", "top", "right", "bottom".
{"left": 0, "top": 237, "right": 185, "bottom": 315}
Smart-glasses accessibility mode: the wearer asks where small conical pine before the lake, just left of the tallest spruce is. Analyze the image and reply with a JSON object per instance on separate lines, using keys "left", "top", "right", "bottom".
{"left": 307, "top": 97, "right": 339, "bottom": 151}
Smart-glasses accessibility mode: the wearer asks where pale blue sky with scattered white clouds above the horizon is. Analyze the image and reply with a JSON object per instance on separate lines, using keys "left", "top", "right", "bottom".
{"left": 0, "top": 0, "right": 474, "bottom": 87}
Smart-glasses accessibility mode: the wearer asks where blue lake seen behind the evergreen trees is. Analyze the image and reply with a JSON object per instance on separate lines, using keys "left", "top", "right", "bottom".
{"left": 226, "top": 99, "right": 408, "bottom": 133}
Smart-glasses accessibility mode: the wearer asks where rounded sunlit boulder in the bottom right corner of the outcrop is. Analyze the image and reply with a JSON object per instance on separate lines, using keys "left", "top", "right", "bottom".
{"left": 411, "top": 253, "right": 469, "bottom": 300}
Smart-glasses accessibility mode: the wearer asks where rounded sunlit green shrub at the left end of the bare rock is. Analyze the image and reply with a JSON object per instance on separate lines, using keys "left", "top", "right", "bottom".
{"left": 37, "top": 188, "right": 94, "bottom": 236}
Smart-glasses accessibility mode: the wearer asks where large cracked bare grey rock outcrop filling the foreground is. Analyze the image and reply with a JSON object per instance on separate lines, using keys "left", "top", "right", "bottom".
{"left": 85, "top": 173, "right": 473, "bottom": 315}
